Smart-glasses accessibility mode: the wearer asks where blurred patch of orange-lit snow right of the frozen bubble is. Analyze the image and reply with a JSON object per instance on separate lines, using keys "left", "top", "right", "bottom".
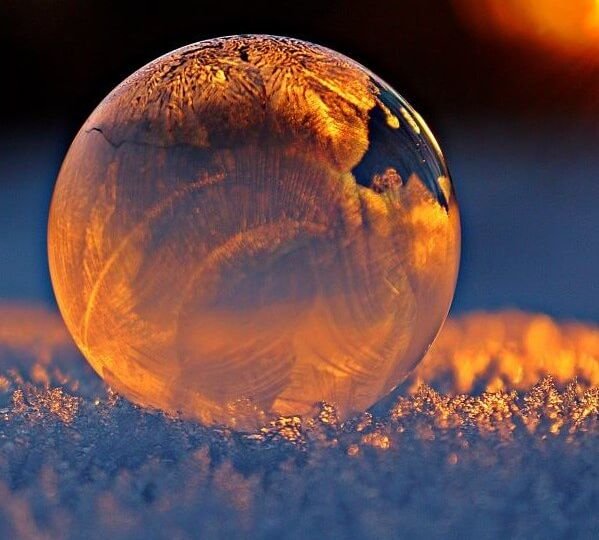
{"left": 411, "top": 311, "right": 599, "bottom": 393}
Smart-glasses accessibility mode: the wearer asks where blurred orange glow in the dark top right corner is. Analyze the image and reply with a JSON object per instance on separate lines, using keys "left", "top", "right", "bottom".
{"left": 454, "top": 0, "right": 599, "bottom": 57}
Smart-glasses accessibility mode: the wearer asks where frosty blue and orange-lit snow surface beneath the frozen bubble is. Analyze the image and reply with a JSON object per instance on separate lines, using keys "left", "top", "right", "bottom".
{"left": 0, "top": 306, "right": 599, "bottom": 539}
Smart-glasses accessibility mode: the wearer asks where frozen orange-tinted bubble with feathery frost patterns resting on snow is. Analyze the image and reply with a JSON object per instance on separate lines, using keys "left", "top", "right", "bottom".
{"left": 48, "top": 36, "right": 460, "bottom": 429}
